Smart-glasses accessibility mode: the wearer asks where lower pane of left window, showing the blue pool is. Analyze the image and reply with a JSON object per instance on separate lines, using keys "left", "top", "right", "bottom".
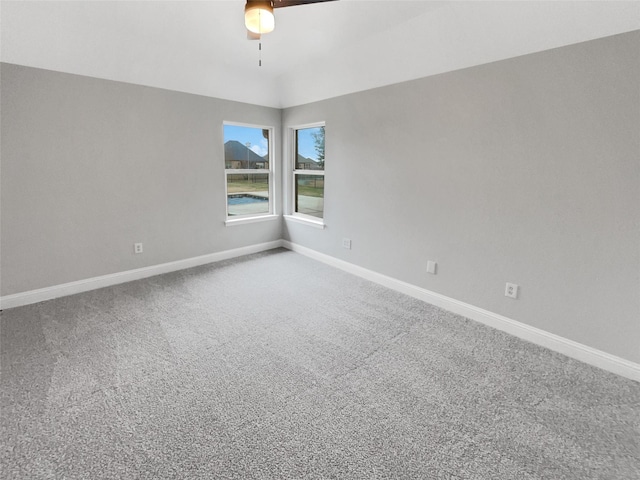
{"left": 227, "top": 173, "right": 269, "bottom": 216}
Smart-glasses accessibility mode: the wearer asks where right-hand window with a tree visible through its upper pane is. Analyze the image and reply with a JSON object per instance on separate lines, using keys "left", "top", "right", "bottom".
{"left": 292, "top": 124, "right": 324, "bottom": 219}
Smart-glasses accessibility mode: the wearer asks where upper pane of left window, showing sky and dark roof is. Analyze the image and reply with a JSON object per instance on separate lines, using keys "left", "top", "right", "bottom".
{"left": 224, "top": 125, "right": 269, "bottom": 170}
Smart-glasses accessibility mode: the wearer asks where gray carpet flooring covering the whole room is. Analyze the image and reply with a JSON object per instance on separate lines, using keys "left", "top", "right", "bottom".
{"left": 0, "top": 250, "right": 640, "bottom": 480}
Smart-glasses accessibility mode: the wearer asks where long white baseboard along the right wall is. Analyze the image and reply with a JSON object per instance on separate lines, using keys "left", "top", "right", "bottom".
{"left": 282, "top": 240, "right": 640, "bottom": 382}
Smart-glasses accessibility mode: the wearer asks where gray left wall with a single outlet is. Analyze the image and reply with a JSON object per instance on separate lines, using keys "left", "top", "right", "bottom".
{"left": 0, "top": 64, "right": 282, "bottom": 295}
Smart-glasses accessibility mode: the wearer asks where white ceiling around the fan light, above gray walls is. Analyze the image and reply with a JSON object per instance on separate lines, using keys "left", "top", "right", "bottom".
{"left": 0, "top": 0, "right": 640, "bottom": 107}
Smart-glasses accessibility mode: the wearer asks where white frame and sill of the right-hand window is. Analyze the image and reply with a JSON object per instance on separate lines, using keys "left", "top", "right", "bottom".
{"left": 285, "top": 121, "right": 327, "bottom": 228}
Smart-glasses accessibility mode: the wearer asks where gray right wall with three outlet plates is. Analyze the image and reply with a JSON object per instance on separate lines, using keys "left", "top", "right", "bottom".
{"left": 283, "top": 32, "right": 640, "bottom": 362}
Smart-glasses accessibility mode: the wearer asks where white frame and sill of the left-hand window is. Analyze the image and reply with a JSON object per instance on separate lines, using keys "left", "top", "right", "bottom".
{"left": 222, "top": 120, "right": 280, "bottom": 226}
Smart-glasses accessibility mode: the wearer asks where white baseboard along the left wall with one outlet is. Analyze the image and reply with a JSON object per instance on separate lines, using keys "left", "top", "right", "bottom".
{"left": 0, "top": 240, "right": 283, "bottom": 310}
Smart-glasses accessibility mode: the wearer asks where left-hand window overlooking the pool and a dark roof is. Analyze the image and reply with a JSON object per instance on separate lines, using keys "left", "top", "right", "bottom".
{"left": 223, "top": 123, "right": 273, "bottom": 219}
